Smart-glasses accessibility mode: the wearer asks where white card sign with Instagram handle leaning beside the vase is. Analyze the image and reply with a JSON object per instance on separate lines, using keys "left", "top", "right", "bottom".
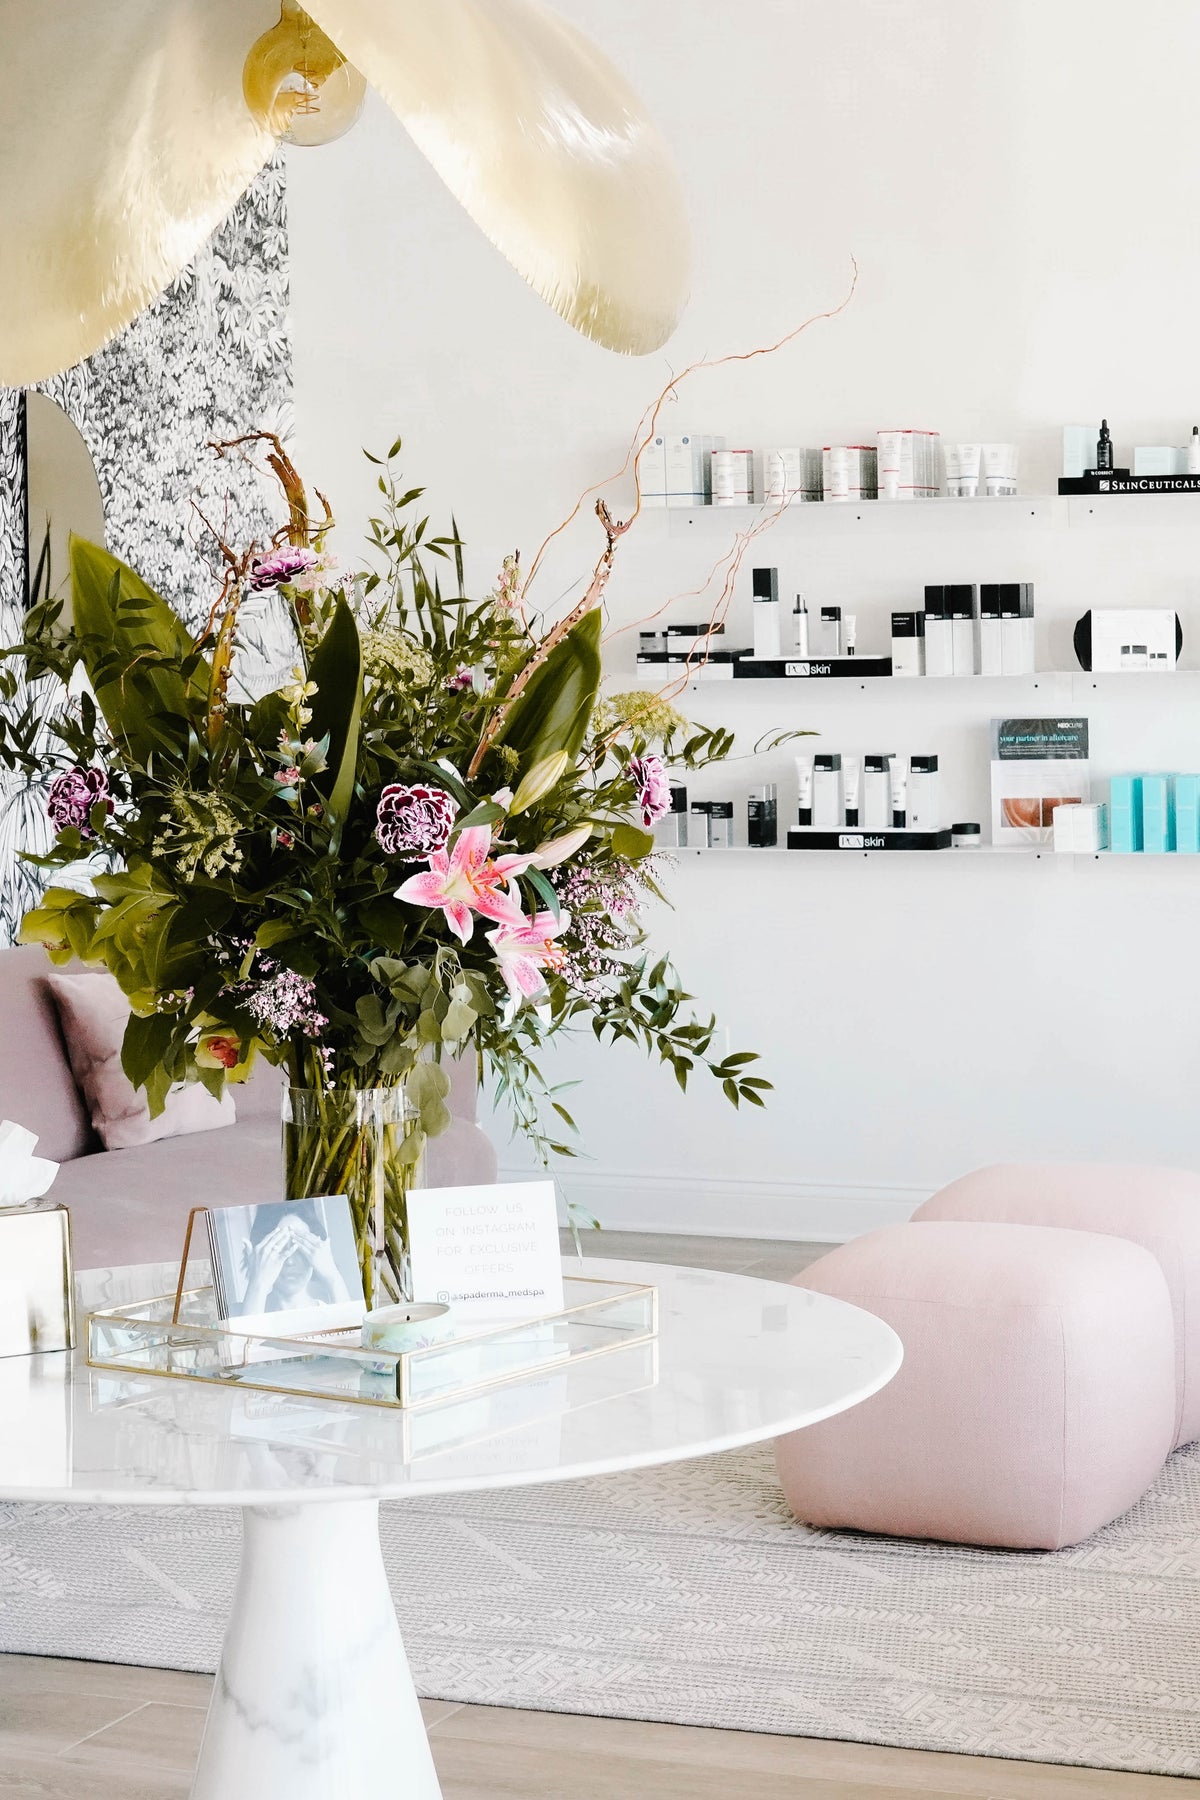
{"left": 408, "top": 1181, "right": 563, "bottom": 1319}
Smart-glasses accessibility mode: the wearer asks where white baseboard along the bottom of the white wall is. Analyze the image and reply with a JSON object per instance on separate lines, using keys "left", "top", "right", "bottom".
{"left": 500, "top": 1165, "right": 932, "bottom": 1244}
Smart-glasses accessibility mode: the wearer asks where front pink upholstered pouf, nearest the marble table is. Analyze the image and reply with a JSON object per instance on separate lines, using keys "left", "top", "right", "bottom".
{"left": 777, "top": 1222, "right": 1175, "bottom": 1550}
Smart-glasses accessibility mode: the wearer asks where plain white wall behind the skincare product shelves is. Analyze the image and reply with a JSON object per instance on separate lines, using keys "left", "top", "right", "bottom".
{"left": 291, "top": 0, "right": 1200, "bottom": 1237}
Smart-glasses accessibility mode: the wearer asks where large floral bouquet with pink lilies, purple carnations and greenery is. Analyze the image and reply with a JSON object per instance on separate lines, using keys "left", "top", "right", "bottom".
{"left": 0, "top": 434, "right": 770, "bottom": 1288}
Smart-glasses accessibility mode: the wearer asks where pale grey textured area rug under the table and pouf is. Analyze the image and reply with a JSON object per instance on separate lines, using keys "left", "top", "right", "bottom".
{"left": 0, "top": 1447, "right": 1200, "bottom": 1775}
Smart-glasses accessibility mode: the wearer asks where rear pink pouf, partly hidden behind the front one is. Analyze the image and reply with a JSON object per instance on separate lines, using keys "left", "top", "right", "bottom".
{"left": 916, "top": 1163, "right": 1200, "bottom": 1444}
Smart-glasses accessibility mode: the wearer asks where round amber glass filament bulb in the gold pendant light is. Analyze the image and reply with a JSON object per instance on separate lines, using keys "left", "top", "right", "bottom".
{"left": 241, "top": 0, "right": 367, "bottom": 146}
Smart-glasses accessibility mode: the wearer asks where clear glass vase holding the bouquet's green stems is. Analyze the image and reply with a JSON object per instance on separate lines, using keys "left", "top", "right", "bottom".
{"left": 282, "top": 1085, "right": 423, "bottom": 1307}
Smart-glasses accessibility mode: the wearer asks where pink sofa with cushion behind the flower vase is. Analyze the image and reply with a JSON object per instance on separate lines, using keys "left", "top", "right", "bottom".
{"left": 0, "top": 947, "right": 497, "bottom": 1269}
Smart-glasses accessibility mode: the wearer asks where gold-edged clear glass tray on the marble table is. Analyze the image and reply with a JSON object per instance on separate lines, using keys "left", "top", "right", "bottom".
{"left": 86, "top": 1274, "right": 658, "bottom": 1411}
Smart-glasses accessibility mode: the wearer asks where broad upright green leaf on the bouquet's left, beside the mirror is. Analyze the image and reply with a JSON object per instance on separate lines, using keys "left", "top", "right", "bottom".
{"left": 70, "top": 533, "right": 209, "bottom": 765}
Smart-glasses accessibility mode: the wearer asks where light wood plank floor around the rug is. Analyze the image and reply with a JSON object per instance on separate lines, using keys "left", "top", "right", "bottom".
{"left": 0, "top": 1231, "right": 1200, "bottom": 1800}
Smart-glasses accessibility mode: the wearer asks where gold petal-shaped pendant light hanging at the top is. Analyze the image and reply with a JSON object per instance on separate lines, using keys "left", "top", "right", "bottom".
{"left": 0, "top": 0, "right": 689, "bottom": 385}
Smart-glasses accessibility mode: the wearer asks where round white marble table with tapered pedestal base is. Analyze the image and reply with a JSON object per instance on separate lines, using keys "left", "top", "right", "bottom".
{"left": 0, "top": 1258, "right": 901, "bottom": 1800}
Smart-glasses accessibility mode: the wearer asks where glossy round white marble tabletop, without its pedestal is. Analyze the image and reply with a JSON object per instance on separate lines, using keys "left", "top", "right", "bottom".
{"left": 0, "top": 1258, "right": 901, "bottom": 1505}
